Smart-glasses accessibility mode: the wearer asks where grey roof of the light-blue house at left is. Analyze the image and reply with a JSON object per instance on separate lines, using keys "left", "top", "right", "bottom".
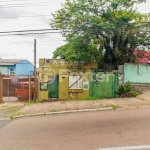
{"left": 0, "top": 59, "right": 25, "bottom": 66}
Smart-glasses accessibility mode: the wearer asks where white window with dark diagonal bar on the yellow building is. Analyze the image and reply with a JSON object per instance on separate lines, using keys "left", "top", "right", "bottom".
{"left": 69, "top": 76, "right": 82, "bottom": 89}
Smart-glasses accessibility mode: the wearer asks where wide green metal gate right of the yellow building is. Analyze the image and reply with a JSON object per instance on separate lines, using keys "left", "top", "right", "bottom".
{"left": 90, "top": 72, "right": 118, "bottom": 98}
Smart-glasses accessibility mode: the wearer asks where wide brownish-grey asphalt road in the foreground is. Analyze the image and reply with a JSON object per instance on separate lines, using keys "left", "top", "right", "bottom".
{"left": 0, "top": 108, "right": 150, "bottom": 150}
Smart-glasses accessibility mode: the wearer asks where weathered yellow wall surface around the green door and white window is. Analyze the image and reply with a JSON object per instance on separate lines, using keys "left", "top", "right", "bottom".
{"left": 39, "top": 59, "right": 97, "bottom": 100}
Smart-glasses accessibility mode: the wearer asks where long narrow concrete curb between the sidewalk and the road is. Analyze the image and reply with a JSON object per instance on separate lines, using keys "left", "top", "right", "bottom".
{"left": 0, "top": 107, "right": 113, "bottom": 121}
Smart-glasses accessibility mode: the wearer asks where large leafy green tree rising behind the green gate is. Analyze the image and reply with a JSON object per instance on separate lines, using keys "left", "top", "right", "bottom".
{"left": 51, "top": 0, "right": 150, "bottom": 67}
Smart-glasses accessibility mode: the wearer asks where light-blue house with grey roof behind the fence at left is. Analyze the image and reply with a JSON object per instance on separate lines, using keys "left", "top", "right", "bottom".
{"left": 0, "top": 59, "right": 34, "bottom": 76}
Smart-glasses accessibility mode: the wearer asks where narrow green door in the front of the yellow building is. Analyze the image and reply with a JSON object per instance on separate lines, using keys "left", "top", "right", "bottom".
{"left": 48, "top": 75, "right": 59, "bottom": 98}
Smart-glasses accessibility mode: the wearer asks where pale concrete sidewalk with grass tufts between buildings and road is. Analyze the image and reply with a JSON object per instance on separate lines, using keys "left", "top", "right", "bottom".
{"left": 0, "top": 91, "right": 150, "bottom": 118}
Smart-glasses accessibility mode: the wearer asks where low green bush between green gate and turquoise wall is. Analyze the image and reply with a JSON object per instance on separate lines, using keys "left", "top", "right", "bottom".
{"left": 115, "top": 83, "right": 140, "bottom": 97}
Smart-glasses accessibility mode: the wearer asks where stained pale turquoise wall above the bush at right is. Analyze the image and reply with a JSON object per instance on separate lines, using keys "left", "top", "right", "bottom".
{"left": 124, "top": 64, "right": 150, "bottom": 83}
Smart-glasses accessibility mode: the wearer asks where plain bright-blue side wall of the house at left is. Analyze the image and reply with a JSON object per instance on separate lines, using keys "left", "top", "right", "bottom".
{"left": 16, "top": 60, "right": 34, "bottom": 76}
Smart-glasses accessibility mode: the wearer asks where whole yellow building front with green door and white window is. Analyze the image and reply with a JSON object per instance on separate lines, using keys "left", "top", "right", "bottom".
{"left": 39, "top": 59, "right": 97, "bottom": 100}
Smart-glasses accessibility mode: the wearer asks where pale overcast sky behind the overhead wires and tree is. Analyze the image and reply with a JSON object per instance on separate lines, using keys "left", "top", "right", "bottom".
{"left": 0, "top": 0, "right": 150, "bottom": 65}
